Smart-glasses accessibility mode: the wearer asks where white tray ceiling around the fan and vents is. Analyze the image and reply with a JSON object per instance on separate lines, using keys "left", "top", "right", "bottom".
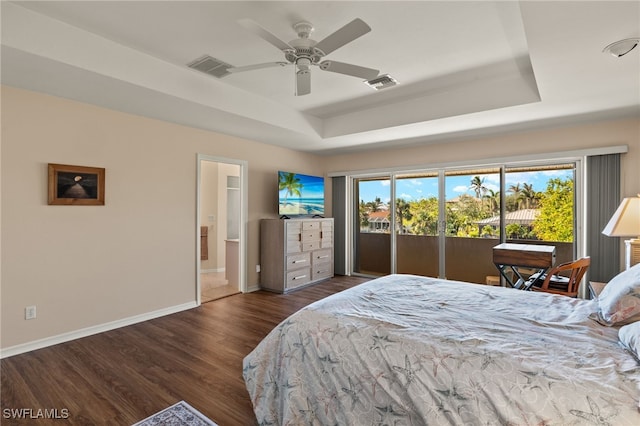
{"left": 1, "top": 1, "right": 640, "bottom": 154}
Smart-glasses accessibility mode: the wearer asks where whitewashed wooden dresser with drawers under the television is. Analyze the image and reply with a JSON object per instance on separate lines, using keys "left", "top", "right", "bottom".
{"left": 260, "top": 218, "right": 333, "bottom": 293}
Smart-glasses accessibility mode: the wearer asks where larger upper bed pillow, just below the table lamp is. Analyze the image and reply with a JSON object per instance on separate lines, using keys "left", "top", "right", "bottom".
{"left": 595, "top": 263, "right": 640, "bottom": 325}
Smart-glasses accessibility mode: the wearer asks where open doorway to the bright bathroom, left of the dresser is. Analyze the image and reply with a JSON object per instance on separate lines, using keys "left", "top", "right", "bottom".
{"left": 197, "top": 154, "right": 246, "bottom": 303}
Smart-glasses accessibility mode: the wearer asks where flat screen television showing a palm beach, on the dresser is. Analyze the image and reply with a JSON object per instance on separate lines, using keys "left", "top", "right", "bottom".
{"left": 278, "top": 171, "right": 324, "bottom": 217}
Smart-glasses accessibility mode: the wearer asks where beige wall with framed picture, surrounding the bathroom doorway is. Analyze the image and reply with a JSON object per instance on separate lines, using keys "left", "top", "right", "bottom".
{"left": 1, "top": 87, "right": 323, "bottom": 349}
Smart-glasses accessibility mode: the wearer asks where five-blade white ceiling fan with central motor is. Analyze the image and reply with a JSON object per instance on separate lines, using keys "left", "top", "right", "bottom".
{"left": 228, "top": 18, "right": 379, "bottom": 96}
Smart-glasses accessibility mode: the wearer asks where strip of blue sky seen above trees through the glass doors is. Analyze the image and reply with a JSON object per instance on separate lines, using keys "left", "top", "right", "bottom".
{"left": 360, "top": 170, "right": 573, "bottom": 203}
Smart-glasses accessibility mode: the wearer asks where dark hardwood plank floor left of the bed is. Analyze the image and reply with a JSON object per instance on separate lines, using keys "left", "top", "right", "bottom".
{"left": 0, "top": 276, "right": 368, "bottom": 426}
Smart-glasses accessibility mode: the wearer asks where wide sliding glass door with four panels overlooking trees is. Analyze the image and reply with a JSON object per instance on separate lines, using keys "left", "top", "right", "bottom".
{"left": 352, "top": 162, "right": 578, "bottom": 284}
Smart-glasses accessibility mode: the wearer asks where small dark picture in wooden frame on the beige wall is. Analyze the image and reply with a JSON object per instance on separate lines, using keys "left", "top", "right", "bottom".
{"left": 49, "top": 163, "right": 104, "bottom": 206}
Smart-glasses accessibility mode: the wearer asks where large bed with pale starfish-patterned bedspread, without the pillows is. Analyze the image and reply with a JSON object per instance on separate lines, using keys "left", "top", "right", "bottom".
{"left": 243, "top": 270, "right": 640, "bottom": 425}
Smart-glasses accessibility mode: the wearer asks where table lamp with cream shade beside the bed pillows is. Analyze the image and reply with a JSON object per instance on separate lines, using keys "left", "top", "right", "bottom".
{"left": 602, "top": 194, "right": 640, "bottom": 269}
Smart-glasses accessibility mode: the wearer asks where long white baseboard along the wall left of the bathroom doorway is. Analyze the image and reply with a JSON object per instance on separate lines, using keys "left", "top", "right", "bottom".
{"left": 0, "top": 302, "right": 198, "bottom": 359}
